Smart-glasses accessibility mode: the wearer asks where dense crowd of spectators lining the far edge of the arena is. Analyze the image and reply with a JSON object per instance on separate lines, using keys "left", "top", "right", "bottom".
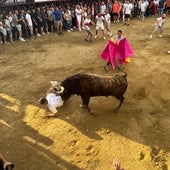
{"left": 0, "top": 0, "right": 170, "bottom": 45}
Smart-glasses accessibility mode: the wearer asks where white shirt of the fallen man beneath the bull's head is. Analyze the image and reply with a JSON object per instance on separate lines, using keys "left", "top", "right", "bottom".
{"left": 46, "top": 93, "right": 63, "bottom": 114}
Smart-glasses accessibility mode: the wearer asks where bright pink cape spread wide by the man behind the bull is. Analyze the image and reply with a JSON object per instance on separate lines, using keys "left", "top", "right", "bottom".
{"left": 100, "top": 38, "right": 134, "bottom": 68}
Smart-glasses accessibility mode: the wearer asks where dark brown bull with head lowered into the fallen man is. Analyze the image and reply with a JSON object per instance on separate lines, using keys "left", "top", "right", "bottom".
{"left": 61, "top": 74, "right": 127, "bottom": 109}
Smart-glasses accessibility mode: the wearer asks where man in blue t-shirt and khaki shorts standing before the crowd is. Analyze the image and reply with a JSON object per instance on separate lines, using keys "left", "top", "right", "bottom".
{"left": 53, "top": 7, "right": 63, "bottom": 35}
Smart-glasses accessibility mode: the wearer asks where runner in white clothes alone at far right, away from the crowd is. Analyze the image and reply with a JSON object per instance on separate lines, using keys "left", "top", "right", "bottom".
{"left": 150, "top": 14, "right": 166, "bottom": 38}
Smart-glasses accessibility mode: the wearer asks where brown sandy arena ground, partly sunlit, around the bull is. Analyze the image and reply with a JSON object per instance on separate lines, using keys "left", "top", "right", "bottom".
{"left": 0, "top": 18, "right": 170, "bottom": 170}
